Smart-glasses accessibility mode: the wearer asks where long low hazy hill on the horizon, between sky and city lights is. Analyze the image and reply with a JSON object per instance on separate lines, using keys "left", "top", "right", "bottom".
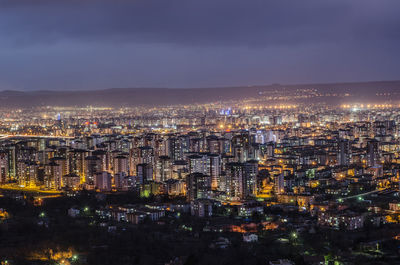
{"left": 0, "top": 81, "right": 400, "bottom": 107}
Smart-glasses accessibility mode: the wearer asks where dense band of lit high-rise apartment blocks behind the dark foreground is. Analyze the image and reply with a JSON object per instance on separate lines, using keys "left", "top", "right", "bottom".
{"left": 0, "top": 106, "right": 400, "bottom": 229}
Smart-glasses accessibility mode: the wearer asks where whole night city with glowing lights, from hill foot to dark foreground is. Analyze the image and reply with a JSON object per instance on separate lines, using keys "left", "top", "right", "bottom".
{"left": 0, "top": 99, "right": 400, "bottom": 265}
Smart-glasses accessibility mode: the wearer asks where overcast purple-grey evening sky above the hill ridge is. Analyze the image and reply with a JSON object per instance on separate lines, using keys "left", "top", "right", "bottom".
{"left": 0, "top": 0, "right": 400, "bottom": 90}
